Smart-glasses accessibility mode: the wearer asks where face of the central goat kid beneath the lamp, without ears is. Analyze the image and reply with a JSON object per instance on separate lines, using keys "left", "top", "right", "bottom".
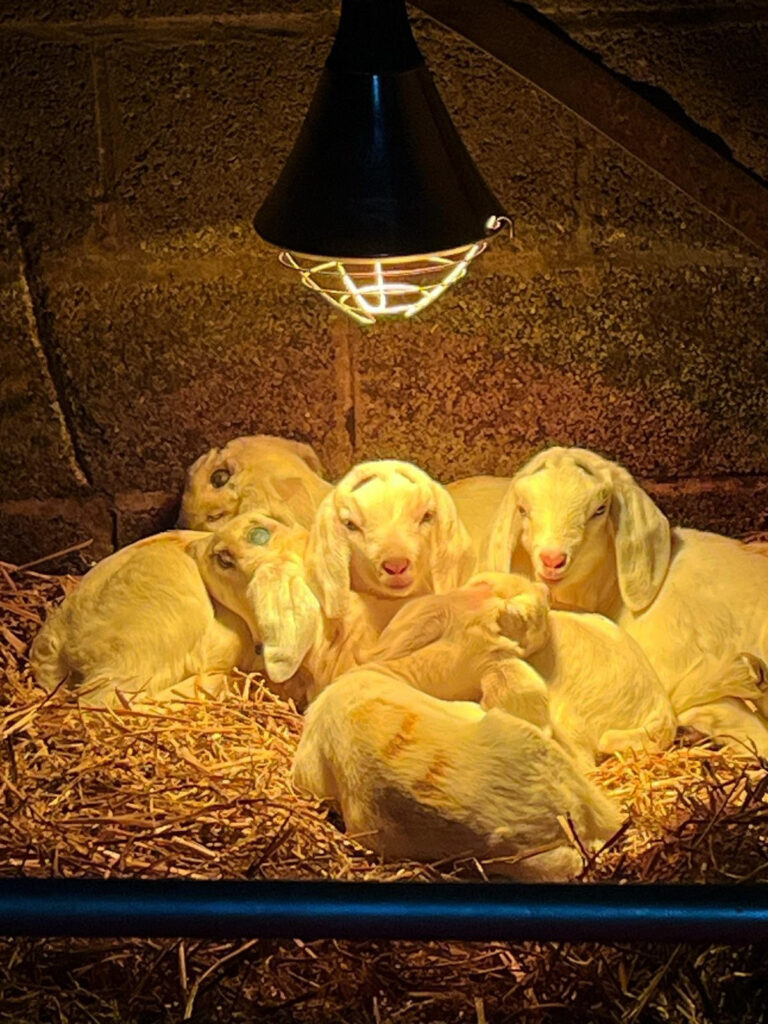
{"left": 337, "top": 476, "right": 437, "bottom": 598}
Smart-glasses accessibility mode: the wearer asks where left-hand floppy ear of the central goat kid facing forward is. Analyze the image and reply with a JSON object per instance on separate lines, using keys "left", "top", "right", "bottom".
{"left": 304, "top": 490, "right": 350, "bottom": 618}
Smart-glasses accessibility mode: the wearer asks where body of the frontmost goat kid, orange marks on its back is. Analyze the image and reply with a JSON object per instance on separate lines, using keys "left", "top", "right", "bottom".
{"left": 293, "top": 666, "right": 621, "bottom": 882}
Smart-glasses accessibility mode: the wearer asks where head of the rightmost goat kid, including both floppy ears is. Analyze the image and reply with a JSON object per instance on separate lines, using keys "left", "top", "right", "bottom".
{"left": 484, "top": 447, "right": 670, "bottom": 610}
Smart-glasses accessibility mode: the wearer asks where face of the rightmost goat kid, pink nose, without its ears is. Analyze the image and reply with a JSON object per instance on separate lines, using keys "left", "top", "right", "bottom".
{"left": 514, "top": 464, "right": 611, "bottom": 587}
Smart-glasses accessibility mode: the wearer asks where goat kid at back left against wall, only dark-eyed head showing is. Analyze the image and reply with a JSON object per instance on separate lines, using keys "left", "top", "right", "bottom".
{"left": 178, "top": 434, "right": 331, "bottom": 530}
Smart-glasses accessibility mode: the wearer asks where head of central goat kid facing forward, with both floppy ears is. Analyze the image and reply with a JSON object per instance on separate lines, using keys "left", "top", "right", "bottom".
{"left": 306, "top": 460, "right": 474, "bottom": 629}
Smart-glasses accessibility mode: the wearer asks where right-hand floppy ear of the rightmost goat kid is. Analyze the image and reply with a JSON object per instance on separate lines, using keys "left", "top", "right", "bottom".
{"left": 610, "top": 465, "right": 671, "bottom": 611}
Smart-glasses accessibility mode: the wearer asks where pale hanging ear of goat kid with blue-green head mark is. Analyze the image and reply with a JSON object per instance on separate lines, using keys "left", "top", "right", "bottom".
{"left": 248, "top": 561, "right": 321, "bottom": 683}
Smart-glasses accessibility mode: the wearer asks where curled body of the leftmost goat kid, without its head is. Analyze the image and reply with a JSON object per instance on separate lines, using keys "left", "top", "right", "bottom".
{"left": 30, "top": 530, "right": 260, "bottom": 705}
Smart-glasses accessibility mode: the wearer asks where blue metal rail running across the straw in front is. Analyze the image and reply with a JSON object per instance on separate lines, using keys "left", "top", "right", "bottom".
{"left": 0, "top": 878, "right": 768, "bottom": 944}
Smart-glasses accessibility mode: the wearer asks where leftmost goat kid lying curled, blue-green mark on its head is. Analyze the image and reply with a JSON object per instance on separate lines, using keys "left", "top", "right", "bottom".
{"left": 31, "top": 512, "right": 378, "bottom": 703}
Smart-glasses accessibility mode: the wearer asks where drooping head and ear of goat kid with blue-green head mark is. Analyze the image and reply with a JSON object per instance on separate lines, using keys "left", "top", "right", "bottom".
{"left": 188, "top": 512, "right": 321, "bottom": 683}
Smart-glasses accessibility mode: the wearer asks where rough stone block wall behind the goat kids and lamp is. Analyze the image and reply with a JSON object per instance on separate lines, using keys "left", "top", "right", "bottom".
{"left": 0, "top": 0, "right": 768, "bottom": 562}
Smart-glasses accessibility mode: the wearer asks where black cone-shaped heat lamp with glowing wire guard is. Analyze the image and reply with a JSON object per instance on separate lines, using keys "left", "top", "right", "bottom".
{"left": 254, "top": 0, "right": 510, "bottom": 324}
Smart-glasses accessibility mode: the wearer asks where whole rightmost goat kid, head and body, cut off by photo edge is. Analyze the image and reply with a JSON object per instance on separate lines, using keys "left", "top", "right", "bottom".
{"left": 482, "top": 447, "right": 768, "bottom": 757}
